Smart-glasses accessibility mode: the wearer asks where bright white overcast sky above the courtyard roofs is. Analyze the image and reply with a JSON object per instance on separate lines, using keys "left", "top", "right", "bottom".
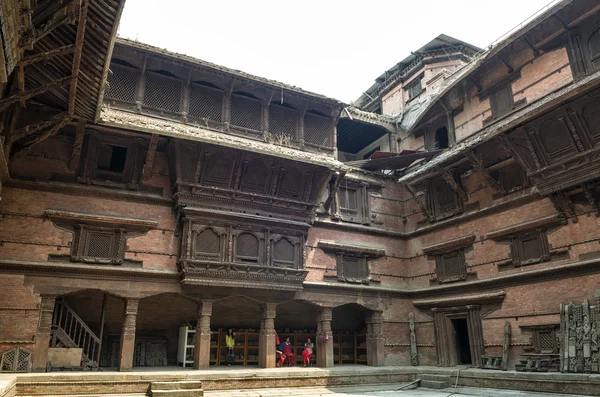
{"left": 119, "top": 0, "right": 550, "bottom": 102}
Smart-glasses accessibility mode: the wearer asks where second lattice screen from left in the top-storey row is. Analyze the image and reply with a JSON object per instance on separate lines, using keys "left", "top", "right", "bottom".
{"left": 143, "top": 72, "right": 183, "bottom": 113}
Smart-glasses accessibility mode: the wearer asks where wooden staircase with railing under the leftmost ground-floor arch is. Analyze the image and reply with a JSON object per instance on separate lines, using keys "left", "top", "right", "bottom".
{"left": 51, "top": 299, "right": 100, "bottom": 365}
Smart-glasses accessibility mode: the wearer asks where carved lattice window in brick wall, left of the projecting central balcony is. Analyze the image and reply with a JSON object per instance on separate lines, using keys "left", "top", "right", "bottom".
{"left": 71, "top": 225, "right": 125, "bottom": 264}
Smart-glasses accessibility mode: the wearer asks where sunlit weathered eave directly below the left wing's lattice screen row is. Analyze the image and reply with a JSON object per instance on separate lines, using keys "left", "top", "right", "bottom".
{"left": 98, "top": 106, "right": 349, "bottom": 171}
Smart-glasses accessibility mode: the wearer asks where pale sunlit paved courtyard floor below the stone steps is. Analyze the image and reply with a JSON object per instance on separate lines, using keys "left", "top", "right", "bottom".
{"left": 204, "top": 385, "right": 592, "bottom": 397}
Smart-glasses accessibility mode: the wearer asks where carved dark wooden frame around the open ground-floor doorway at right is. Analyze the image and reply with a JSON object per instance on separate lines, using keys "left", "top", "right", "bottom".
{"left": 432, "top": 305, "right": 484, "bottom": 367}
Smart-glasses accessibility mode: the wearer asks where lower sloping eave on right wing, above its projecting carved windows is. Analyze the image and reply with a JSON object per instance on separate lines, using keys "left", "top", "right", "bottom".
{"left": 399, "top": 71, "right": 600, "bottom": 183}
